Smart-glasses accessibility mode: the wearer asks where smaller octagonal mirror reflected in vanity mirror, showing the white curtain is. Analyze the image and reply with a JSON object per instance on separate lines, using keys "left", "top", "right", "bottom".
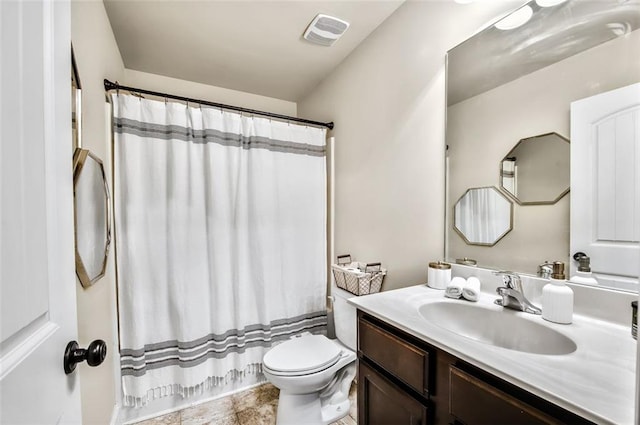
{"left": 453, "top": 186, "right": 513, "bottom": 246}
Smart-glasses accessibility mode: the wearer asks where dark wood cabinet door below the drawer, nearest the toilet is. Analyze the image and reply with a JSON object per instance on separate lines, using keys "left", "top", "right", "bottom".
{"left": 358, "top": 360, "right": 427, "bottom": 425}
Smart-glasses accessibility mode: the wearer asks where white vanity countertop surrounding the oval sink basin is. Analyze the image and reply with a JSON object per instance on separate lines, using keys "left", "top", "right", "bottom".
{"left": 349, "top": 285, "right": 636, "bottom": 425}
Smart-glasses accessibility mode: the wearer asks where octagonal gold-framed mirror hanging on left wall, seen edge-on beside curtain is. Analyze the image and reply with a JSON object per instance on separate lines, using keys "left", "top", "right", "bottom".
{"left": 73, "top": 148, "right": 111, "bottom": 288}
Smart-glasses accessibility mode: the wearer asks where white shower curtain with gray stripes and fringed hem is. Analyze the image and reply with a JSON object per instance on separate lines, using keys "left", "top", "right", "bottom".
{"left": 112, "top": 94, "right": 326, "bottom": 406}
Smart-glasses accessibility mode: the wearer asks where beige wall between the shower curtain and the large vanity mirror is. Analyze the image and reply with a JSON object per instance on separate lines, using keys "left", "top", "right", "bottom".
{"left": 298, "top": 1, "right": 514, "bottom": 290}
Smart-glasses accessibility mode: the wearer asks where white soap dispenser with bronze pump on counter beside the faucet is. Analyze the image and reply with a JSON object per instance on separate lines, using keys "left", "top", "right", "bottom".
{"left": 542, "top": 261, "right": 573, "bottom": 324}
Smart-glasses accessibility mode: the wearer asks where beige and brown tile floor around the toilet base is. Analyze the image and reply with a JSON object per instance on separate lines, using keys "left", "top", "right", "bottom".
{"left": 135, "top": 383, "right": 357, "bottom": 425}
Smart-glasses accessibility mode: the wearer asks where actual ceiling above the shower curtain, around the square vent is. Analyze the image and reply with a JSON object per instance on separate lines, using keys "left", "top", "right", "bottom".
{"left": 103, "top": 0, "right": 404, "bottom": 101}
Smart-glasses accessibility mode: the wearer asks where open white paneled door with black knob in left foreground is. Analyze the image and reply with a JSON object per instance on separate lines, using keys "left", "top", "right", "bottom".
{"left": 0, "top": 0, "right": 81, "bottom": 424}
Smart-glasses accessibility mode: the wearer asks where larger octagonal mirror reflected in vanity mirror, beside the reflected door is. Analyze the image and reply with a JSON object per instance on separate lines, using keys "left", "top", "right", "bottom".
{"left": 500, "top": 133, "right": 570, "bottom": 205}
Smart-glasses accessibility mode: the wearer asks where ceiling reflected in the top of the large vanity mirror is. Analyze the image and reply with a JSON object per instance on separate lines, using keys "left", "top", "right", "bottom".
{"left": 447, "top": 0, "right": 640, "bottom": 105}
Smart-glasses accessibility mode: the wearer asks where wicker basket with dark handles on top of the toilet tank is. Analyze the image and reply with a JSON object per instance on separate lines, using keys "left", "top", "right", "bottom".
{"left": 331, "top": 255, "right": 387, "bottom": 295}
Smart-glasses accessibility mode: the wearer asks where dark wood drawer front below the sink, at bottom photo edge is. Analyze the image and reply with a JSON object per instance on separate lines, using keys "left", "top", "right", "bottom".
{"left": 449, "top": 366, "right": 562, "bottom": 425}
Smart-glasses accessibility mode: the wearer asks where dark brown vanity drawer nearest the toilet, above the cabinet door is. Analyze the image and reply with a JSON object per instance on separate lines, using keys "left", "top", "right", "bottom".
{"left": 358, "top": 319, "right": 429, "bottom": 395}
